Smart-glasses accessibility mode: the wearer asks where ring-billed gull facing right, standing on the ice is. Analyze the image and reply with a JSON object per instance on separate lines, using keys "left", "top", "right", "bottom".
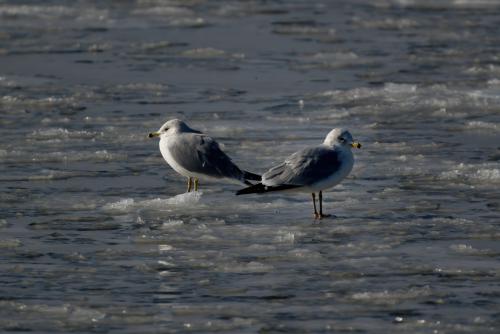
{"left": 236, "top": 129, "right": 361, "bottom": 219}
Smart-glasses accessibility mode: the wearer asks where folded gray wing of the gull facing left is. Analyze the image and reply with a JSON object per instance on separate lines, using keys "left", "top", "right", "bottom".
{"left": 168, "top": 133, "right": 243, "bottom": 180}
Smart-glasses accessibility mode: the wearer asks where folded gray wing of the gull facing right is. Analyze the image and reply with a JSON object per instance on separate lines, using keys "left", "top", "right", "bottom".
{"left": 262, "top": 146, "right": 341, "bottom": 186}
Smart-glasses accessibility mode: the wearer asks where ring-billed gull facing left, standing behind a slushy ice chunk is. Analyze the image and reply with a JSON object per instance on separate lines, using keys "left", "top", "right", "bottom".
{"left": 149, "top": 119, "right": 261, "bottom": 192}
